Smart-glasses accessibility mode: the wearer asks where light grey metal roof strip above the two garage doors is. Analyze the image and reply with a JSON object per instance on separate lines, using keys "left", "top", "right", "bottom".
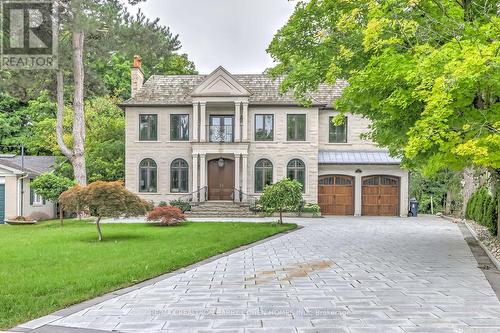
{"left": 319, "top": 150, "right": 401, "bottom": 164}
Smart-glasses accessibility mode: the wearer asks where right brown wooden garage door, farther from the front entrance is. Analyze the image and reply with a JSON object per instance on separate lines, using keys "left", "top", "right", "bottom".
{"left": 361, "top": 175, "right": 399, "bottom": 216}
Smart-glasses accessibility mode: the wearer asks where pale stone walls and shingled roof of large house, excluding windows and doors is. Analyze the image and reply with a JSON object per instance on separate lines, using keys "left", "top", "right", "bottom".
{"left": 122, "top": 68, "right": 408, "bottom": 216}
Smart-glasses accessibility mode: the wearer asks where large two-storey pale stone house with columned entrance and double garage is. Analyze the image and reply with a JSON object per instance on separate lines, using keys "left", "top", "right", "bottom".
{"left": 122, "top": 57, "right": 408, "bottom": 216}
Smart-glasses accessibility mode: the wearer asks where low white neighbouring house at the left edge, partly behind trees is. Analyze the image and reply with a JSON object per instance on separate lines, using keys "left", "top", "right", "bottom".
{"left": 0, "top": 155, "right": 55, "bottom": 223}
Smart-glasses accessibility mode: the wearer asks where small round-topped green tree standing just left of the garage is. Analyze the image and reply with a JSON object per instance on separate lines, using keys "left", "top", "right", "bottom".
{"left": 259, "top": 178, "right": 302, "bottom": 223}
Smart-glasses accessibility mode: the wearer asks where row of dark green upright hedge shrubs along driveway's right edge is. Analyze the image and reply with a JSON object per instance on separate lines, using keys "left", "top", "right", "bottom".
{"left": 465, "top": 187, "right": 499, "bottom": 235}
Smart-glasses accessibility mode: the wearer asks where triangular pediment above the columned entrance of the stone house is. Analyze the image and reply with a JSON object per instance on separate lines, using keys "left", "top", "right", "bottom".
{"left": 191, "top": 66, "right": 251, "bottom": 97}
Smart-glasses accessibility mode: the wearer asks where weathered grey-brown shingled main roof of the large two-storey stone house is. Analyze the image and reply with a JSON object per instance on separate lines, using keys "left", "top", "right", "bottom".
{"left": 122, "top": 74, "right": 347, "bottom": 106}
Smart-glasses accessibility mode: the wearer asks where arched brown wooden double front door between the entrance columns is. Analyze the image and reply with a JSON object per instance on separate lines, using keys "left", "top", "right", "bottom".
{"left": 208, "top": 159, "right": 234, "bottom": 200}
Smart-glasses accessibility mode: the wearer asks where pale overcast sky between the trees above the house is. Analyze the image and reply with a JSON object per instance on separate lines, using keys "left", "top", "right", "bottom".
{"left": 127, "top": 0, "right": 296, "bottom": 74}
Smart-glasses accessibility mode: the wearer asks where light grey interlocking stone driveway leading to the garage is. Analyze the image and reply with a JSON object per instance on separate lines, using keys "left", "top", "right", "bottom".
{"left": 42, "top": 217, "right": 500, "bottom": 333}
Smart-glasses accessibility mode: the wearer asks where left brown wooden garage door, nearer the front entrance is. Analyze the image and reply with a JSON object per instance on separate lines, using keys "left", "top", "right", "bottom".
{"left": 318, "top": 175, "right": 354, "bottom": 215}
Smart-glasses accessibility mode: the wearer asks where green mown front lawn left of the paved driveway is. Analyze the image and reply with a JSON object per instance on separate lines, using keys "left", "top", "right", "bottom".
{"left": 0, "top": 221, "right": 296, "bottom": 329}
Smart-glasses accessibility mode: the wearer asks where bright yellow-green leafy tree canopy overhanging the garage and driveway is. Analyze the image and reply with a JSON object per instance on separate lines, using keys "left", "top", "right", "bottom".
{"left": 268, "top": 0, "right": 500, "bottom": 174}
